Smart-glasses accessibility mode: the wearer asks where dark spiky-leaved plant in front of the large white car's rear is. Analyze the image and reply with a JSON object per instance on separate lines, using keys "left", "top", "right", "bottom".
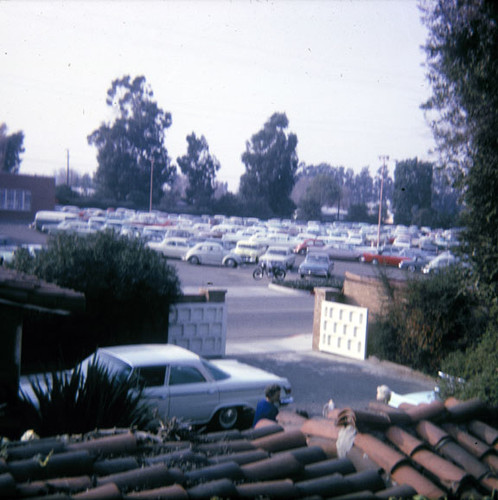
{"left": 21, "top": 360, "right": 154, "bottom": 436}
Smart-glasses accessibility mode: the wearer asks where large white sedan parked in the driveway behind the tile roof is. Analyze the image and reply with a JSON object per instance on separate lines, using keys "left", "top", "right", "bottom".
{"left": 82, "top": 344, "right": 292, "bottom": 429}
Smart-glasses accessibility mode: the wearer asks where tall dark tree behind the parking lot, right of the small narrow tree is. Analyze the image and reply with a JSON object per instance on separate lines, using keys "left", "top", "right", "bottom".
{"left": 239, "top": 113, "right": 298, "bottom": 216}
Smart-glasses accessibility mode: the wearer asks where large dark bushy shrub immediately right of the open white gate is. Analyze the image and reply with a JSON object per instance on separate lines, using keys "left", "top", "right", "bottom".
{"left": 369, "top": 268, "right": 486, "bottom": 374}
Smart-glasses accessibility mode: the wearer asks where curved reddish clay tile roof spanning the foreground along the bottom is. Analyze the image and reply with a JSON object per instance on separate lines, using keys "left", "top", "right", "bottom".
{"left": 0, "top": 399, "right": 498, "bottom": 499}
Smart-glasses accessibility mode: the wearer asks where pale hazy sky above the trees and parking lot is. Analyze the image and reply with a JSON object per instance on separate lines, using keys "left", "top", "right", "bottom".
{"left": 0, "top": 0, "right": 434, "bottom": 192}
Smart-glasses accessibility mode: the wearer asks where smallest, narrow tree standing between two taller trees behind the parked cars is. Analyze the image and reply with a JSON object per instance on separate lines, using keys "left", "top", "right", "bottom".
{"left": 176, "top": 132, "right": 220, "bottom": 208}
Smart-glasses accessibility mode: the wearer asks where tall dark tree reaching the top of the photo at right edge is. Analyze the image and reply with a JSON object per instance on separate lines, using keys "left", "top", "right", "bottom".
{"left": 422, "top": 0, "right": 498, "bottom": 300}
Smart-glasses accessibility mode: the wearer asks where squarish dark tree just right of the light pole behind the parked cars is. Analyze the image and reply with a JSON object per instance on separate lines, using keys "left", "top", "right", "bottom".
{"left": 392, "top": 158, "right": 432, "bottom": 226}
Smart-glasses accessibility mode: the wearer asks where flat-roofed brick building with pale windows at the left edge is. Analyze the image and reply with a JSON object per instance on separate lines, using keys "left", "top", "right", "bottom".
{"left": 0, "top": 172, "right": 55, "bottom": 221}
